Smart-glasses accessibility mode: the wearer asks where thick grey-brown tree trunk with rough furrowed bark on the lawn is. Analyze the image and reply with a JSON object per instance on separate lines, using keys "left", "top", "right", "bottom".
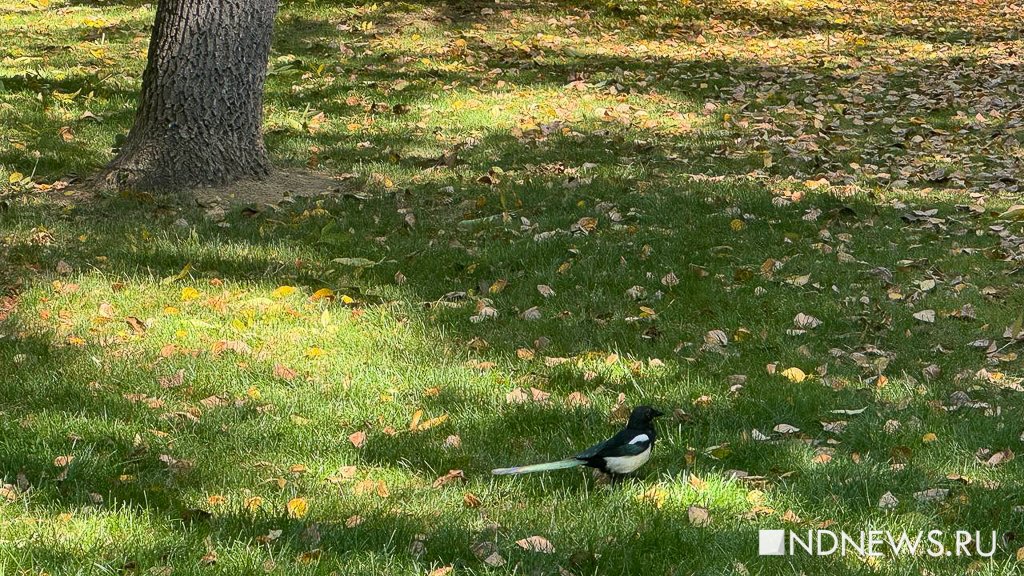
{"left": 100, "top": 0, "right": 278, "bottom": 191}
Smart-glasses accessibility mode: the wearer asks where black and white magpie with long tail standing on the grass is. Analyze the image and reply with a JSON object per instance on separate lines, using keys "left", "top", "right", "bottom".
{"left": 490, "top": 406, "right": 663, "bottom": 478}
